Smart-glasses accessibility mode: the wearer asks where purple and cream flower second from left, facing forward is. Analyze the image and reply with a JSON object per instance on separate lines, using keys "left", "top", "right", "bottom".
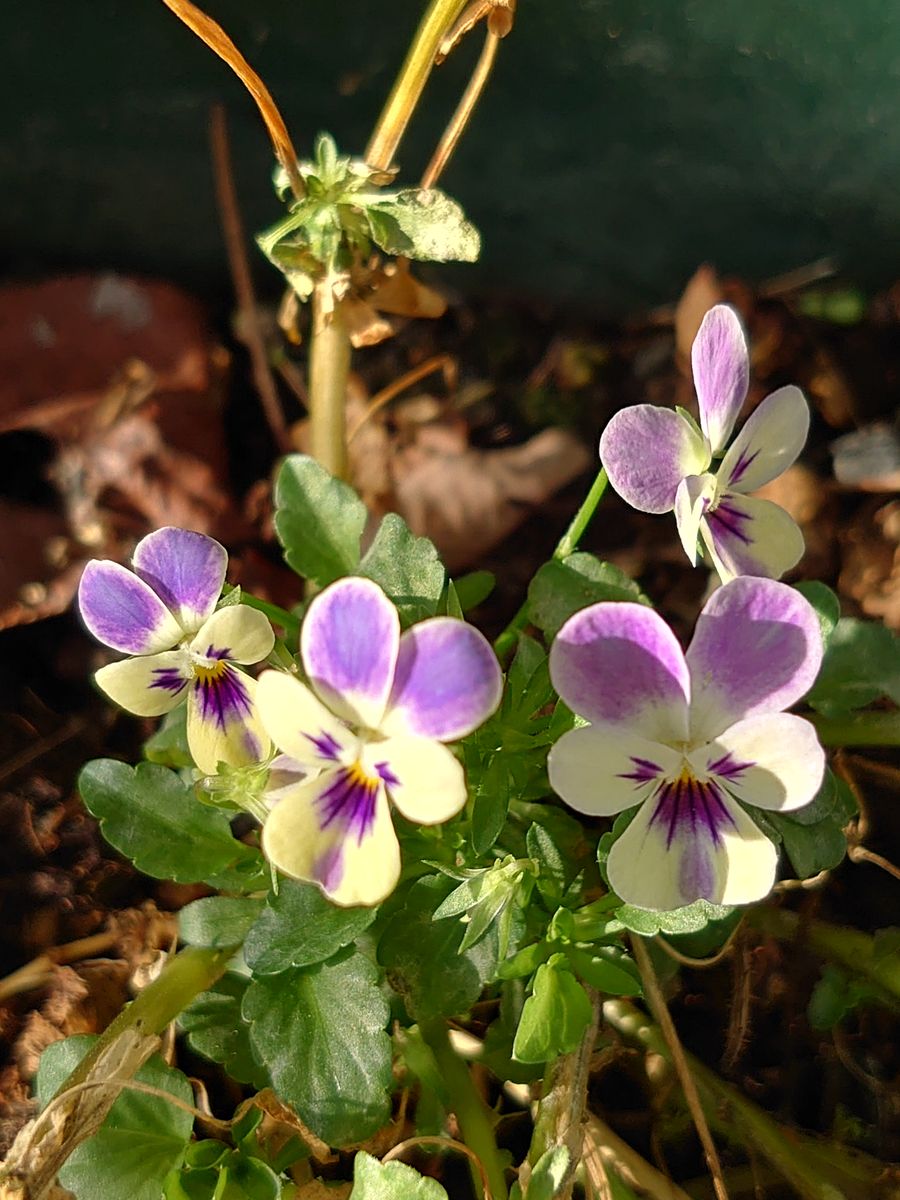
{"left": 257, "top": 577, "right": 503, "bottom": 905}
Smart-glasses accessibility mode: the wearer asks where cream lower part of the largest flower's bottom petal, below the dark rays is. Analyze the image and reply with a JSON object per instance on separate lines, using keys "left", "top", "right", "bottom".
{"left": 606, "top": 796, "right": 778, "bottom": 912}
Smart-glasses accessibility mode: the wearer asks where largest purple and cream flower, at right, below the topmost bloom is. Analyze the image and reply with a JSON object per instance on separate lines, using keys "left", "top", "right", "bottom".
{"left": 548, "top": 577, "right": 824, "bottom": 911}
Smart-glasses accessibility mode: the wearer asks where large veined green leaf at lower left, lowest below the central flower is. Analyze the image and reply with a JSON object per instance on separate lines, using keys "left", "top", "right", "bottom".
{"left": 244, "top": 952, "right": 391, "bottom": 1146}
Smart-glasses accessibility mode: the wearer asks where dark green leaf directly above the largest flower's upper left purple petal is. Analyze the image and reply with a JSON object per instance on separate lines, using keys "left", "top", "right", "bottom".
{"left": 528, "top": 551, "right": 649, "bottom": 640}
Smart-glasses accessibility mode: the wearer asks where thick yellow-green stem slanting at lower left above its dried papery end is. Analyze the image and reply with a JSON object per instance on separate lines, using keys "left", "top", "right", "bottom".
{"left": 56, "top": 946, "right": 238, "bottom": 1096}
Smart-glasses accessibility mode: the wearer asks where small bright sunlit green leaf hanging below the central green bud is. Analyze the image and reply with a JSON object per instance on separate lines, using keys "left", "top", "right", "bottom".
{"left": 512, "top": 954, "right": 593, "bottom": 1062}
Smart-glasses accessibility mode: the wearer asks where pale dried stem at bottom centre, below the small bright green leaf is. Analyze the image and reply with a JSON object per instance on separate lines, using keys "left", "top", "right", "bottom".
{"left": 520, "top": 988, "right": 600, "bottom": 1200}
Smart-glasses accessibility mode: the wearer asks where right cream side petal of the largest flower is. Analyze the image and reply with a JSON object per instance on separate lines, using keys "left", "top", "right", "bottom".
{"left": 691, "top": 713, "right": 826, "bottom": 812}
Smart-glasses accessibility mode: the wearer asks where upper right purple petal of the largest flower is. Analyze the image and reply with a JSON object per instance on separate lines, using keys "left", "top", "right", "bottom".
{"left": 686, "top": 576, "right": 822, "bottom": 745}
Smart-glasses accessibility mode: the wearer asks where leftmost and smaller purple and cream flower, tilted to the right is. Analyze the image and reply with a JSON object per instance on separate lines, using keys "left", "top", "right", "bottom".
{"left": 78, "top": 526, "right": 275, "bottom": 775}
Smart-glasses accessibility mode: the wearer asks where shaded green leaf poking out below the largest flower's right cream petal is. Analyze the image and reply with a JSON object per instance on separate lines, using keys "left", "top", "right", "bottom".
{"left": 751, "top": 770, "right": 857, "bottom": 880}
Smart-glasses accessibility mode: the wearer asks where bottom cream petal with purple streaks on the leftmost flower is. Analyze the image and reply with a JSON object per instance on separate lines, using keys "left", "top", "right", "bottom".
{"left": 187, "top": 662, "right": 270, "bottom": 775}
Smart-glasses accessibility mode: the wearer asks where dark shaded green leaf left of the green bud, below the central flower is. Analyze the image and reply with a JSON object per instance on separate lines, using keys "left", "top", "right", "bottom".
{"left": 378, "top": 875, "right": 497, "bottom": 1021}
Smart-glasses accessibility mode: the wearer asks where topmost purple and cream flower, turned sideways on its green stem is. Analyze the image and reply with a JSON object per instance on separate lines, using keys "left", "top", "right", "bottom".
{"left": 600, "top": 305, "right": 809, "bottom": 582}
